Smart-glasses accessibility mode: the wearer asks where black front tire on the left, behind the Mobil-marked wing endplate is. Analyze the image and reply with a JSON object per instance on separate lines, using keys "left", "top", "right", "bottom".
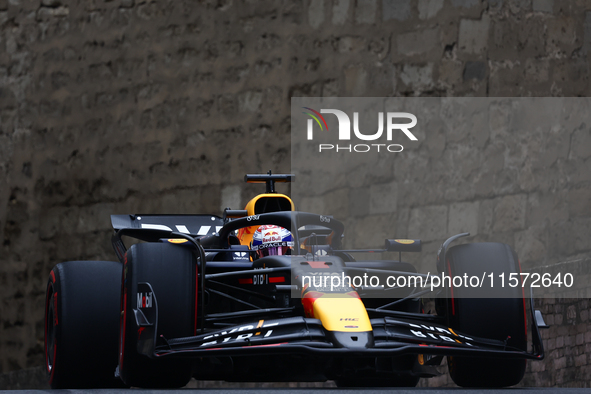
{"left": 119, "top": 243, "right": 197, "bottom": 388}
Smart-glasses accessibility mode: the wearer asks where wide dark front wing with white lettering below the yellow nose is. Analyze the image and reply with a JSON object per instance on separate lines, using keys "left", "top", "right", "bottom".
{"left": 133, "top": 283, "right": 544, "bottom": 360}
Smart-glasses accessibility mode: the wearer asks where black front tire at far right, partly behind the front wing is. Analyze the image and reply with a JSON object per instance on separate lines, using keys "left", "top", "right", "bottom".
{"left": 446, "top": 243, "right": 527, "bottom": 387}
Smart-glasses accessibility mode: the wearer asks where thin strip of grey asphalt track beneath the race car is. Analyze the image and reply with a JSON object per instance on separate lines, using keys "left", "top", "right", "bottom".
{"left": 2, "top": 387, "right": 590, "bottom": 394}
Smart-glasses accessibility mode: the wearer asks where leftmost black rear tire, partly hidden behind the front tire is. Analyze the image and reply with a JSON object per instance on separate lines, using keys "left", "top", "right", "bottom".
{"left": 45, "top": 261, "right": 123, "bottom": 389}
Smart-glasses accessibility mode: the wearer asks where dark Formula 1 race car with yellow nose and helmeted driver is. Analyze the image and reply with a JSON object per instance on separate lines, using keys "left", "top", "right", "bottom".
{"left": 45, "top": 171, "right": 545, "bottom": 388}
